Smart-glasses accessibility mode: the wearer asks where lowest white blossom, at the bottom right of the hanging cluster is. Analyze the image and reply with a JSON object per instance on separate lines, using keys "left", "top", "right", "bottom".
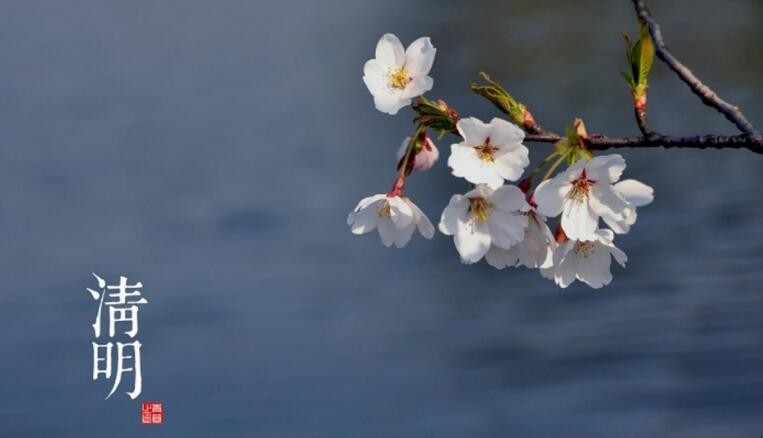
{"left": 553, "top": 230, "right": 628, "bottom": 289}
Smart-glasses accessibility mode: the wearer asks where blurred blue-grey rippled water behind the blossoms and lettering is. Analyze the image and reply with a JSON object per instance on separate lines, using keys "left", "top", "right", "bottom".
{"left": 0, "top": 0, "right": 763, "bottom": 438}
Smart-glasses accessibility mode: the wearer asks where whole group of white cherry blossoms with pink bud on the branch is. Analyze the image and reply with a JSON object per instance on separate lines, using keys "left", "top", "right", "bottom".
{"left": 347, "top": 34, "right": 653, "bottom": 288}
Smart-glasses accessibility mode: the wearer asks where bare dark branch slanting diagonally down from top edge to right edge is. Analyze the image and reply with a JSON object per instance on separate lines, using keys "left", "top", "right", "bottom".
{"left": 633, "top": 0, "right": 760, "bottom": 137}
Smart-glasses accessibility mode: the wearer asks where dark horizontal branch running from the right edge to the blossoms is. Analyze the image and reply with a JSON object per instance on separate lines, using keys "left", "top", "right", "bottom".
{"left": 525, "top": 134, "right": 763, "bottom": 154}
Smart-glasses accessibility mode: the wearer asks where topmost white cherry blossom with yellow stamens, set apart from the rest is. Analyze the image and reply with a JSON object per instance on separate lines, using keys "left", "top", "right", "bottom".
{"left": 363, "top": 33, "right": 437, "bottom": 115}
